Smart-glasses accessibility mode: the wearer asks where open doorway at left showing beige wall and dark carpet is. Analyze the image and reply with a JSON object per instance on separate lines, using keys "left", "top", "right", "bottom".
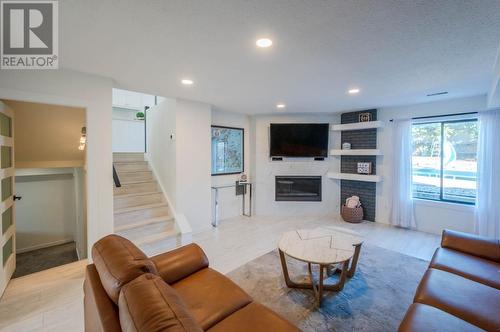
{"left": 0, "top": 100, "right": 87, "bottom": 278}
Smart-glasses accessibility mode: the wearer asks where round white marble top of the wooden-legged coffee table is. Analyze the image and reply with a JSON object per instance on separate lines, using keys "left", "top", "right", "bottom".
{"left": 278, "top": 226, "right": 363, "bottom": 265}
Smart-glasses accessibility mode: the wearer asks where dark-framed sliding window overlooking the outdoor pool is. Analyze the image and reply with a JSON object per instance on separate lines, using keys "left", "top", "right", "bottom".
{"left": 412, "top": 118, "right": 478, "bottom": 204}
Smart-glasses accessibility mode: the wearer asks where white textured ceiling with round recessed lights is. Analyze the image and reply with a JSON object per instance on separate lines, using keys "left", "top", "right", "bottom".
{"left": 59, "top": 0, "right": 500, "bottom": 114}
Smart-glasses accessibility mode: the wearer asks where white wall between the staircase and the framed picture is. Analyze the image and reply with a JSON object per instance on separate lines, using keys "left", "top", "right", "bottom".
{"left": 147, "top": 98, "right": 211, "bottom": 232}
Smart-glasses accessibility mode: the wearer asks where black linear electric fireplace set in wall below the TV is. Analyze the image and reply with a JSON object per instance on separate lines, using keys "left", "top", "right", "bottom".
{"left": 275, "top": 176, "right": 321, "bottom": 202}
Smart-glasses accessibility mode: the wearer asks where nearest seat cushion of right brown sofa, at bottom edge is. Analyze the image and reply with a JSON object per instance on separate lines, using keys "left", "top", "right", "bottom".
{"left": 398, "top": 303, "right": 483, "bottom": 332}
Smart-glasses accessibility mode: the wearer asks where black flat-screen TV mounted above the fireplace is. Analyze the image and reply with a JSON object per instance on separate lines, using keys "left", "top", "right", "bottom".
{"left": 270, "top": 123, "right": 330, "bottom": 157}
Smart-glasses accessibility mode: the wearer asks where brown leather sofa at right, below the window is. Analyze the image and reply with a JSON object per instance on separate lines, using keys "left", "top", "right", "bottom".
{"left": 399, "top": 230, "right": 500, "bottom": 332}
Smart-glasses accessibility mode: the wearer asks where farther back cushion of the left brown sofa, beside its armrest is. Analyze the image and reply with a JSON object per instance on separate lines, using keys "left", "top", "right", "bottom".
{"left": 92, "top": 234, "right": 157, "bottom": 304}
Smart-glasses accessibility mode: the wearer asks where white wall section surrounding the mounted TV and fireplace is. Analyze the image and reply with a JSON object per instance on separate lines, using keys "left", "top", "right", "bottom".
{"left": 251, "top": 114, "right": 340, "bottom": 216}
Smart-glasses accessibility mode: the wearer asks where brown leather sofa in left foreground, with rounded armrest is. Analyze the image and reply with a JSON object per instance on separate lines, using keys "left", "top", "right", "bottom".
{"left": 84, "top": 235, "right": 299, "bottom": 332}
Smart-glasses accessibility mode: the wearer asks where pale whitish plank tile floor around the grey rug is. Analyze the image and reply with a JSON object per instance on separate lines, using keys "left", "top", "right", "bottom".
{"left": 0, "top": 217, "right": 440, "bottom": 332}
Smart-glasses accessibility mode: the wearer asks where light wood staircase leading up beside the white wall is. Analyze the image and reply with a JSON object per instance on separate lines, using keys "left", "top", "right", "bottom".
{"left": 113, "top": 153, "right": 179, "bottom": 254}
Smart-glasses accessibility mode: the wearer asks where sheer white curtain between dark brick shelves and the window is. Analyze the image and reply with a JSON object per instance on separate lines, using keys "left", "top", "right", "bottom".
{"left": 391, "top": 119, "right": 417, "bottom": 228}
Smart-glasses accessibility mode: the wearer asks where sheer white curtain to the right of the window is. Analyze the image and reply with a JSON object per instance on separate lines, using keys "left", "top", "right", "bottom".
{"left": 475, "top": 110, "right": 500, "bottom": 239}
